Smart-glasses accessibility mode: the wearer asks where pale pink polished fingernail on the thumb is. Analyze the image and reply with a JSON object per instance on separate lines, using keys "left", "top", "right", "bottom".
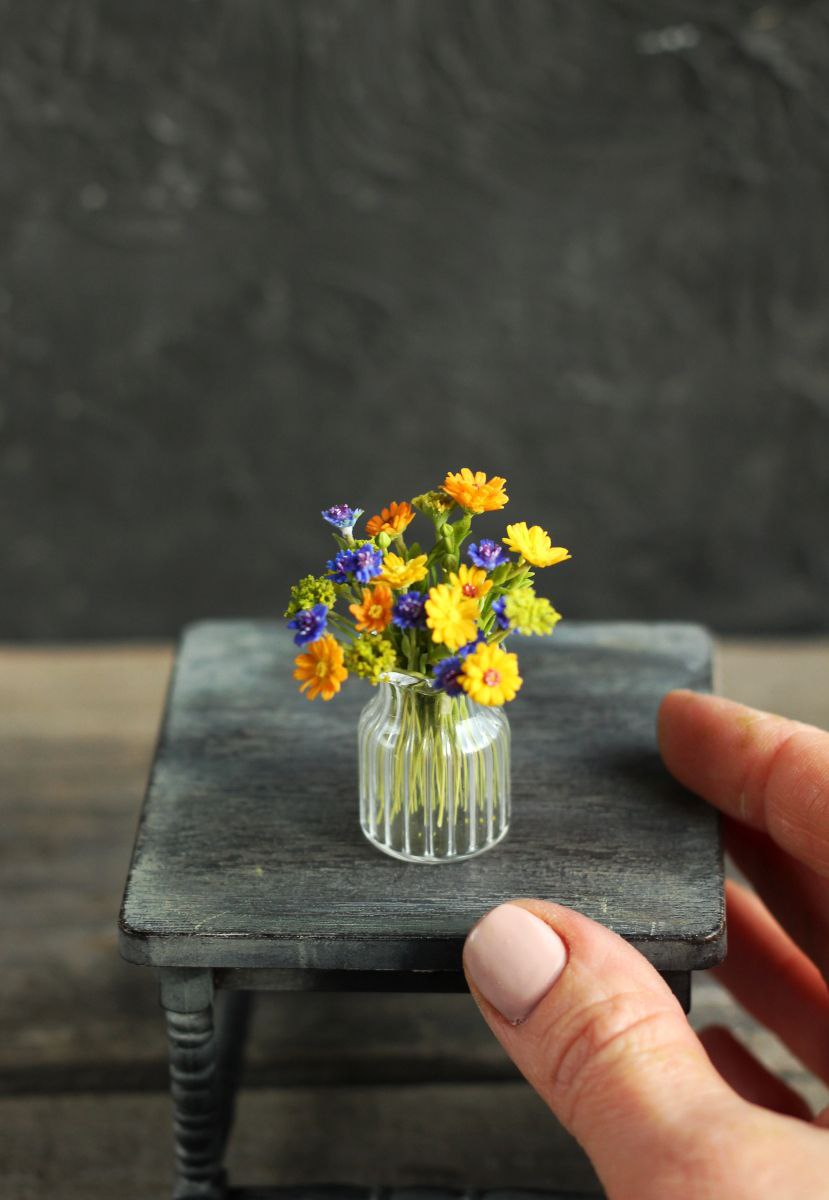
{"left": 463, "top": 904, "right": 567, "bottom": 1025}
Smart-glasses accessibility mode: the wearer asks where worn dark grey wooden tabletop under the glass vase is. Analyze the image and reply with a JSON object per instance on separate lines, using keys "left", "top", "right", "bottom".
{"left": 120, "top": 620, "right": 725, "bottom": 971}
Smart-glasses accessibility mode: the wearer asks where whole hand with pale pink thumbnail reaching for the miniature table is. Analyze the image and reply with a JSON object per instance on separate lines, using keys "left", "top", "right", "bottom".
{"left": 464, "top": 691, "right": 829, "bottom": 1200}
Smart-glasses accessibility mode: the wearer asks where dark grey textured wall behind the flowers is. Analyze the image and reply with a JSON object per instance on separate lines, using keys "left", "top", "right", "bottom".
{"left": 0, "top": 0, "right": 829, "bottom": 637}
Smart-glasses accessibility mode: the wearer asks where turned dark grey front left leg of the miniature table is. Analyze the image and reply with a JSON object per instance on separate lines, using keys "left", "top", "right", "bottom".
{"left": 160, "top": 967, "right": 226, "bottom": 1200}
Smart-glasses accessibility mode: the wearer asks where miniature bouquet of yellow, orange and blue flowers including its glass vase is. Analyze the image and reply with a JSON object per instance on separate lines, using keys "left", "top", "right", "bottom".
{"left": 286, "top": 467, "right": 570, "bottom": 862}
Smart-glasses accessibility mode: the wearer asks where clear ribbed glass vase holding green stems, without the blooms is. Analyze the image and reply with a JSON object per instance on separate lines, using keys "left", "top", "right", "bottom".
{"left": 358, "top": 672, "right": 510, "bottom": 863}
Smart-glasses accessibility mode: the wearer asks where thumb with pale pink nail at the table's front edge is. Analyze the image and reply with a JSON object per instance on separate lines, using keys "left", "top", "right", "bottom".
{"left": 463, "top": 900, "right": 744, "bottom": 1200}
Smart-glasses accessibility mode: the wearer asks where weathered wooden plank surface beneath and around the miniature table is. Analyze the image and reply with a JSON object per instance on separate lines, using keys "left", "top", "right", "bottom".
{"left": 0, "top": 641, "right": 829, "bottom": 1200}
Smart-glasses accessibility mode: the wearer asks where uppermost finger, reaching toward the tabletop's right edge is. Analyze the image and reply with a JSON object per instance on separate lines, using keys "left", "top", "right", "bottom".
{"left": 657, "top": 691, "right": 829, "bottom": 876}
